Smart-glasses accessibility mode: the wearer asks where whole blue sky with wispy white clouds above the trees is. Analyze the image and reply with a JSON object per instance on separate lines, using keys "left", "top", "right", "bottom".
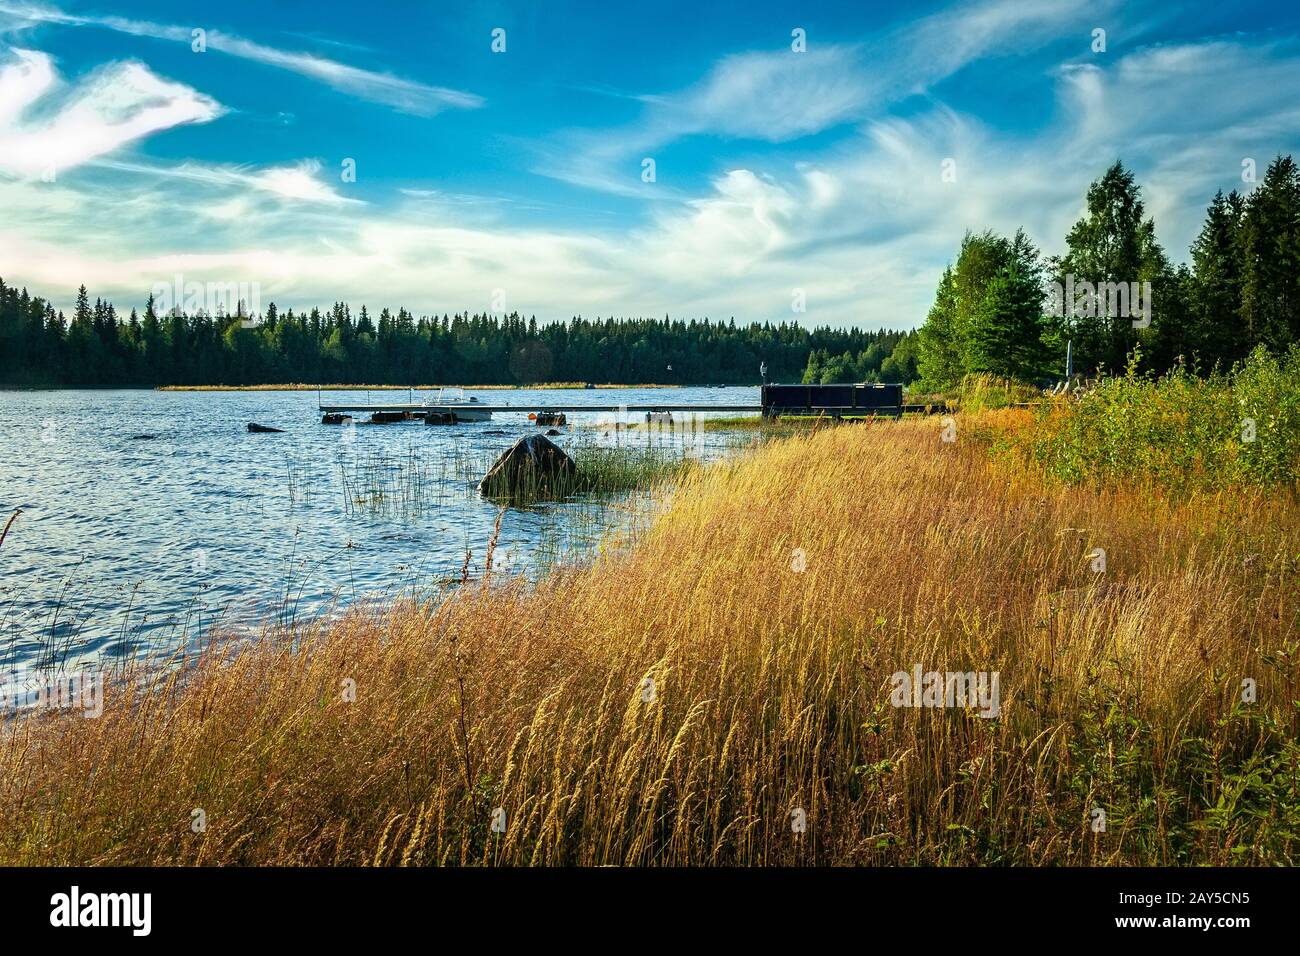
{"left": 0, "top": 0, "right": 1300, "bottom": 328}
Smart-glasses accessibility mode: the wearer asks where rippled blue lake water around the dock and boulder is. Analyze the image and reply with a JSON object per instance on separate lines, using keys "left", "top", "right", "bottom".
{"left": 0, "top": 388, "right": 758, "bottom": 667}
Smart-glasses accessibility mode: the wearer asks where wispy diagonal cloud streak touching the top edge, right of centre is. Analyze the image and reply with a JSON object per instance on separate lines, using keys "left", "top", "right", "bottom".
{"left": 533, "top": 0, "right": 1117, "bottom": 200}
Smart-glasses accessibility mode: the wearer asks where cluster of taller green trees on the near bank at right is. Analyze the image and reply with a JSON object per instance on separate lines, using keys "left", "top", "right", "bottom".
{"left": 915, "top": 156, "right": 1300, "bottom": 390}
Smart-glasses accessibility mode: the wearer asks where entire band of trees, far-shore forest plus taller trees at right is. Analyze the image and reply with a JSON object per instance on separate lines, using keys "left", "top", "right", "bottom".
{"left": 0, "top": 156, "right": 1300, "bottom": 392}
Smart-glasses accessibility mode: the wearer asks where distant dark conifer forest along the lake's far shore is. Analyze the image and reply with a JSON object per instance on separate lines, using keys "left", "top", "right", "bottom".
{"left": 0, "top": 278, "right": 902, "bottom": 386}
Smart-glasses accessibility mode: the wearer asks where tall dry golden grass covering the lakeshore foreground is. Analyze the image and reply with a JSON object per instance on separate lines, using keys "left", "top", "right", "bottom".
{"left": 0, "top": 412, "right": 1300, "bottom": 865}
